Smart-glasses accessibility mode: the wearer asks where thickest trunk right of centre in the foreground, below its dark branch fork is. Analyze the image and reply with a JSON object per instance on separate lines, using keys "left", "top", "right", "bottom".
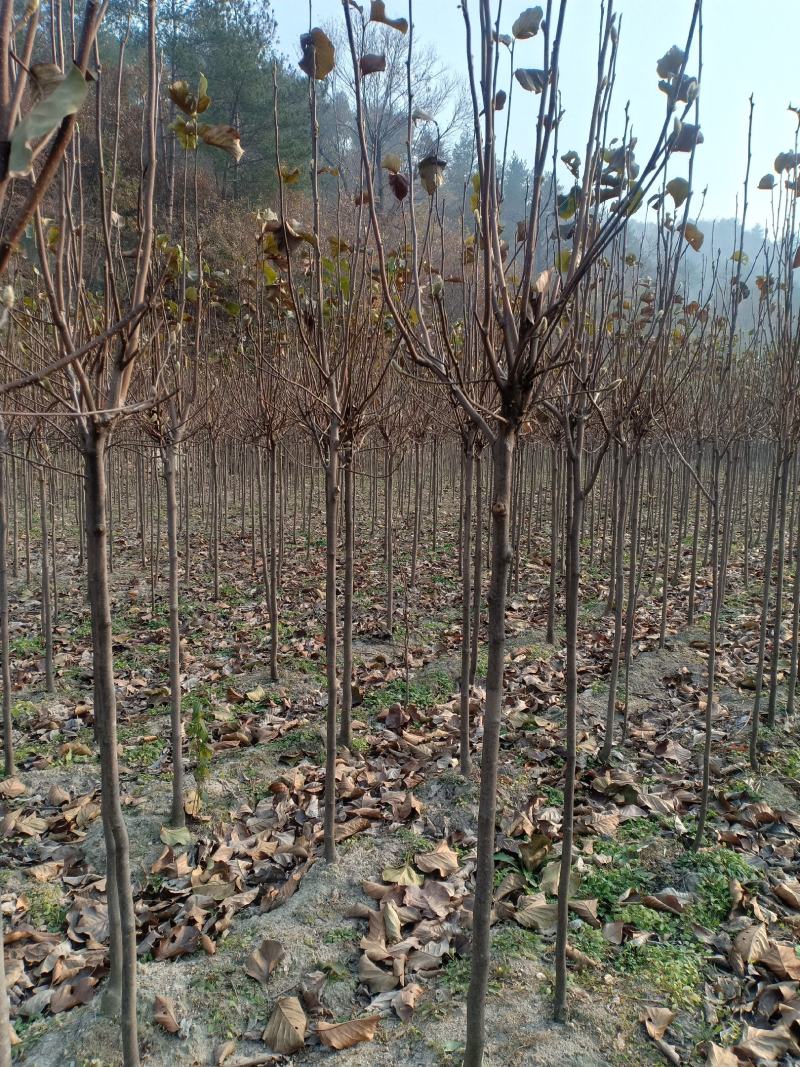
{"left": 464, "top": 421, "right": 516, "bottom": 1067}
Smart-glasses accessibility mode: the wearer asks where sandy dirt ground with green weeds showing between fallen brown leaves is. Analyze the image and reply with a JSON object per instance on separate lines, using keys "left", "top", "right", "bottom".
{"left": 0, "top": 518, "right": 800, "bottom": 1067}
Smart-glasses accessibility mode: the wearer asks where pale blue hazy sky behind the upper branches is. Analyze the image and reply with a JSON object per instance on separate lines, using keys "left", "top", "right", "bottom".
{"left": 273, "top": 0, "right": 800, "bottom": 224}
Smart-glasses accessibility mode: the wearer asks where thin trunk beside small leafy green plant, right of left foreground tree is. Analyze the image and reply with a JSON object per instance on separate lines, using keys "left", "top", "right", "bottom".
{"left": 161, "top": 436, "right": 186, "bottom": 830}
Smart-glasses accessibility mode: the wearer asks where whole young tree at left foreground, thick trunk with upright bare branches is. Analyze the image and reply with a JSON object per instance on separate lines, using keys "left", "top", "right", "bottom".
{"left": 0, "top": 0, "right": 241, "bottom": 1067}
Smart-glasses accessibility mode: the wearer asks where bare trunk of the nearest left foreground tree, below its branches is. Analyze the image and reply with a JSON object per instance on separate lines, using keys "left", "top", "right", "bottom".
{"left": 84, "top": 429, "right": 139, "bottom": 1067}
